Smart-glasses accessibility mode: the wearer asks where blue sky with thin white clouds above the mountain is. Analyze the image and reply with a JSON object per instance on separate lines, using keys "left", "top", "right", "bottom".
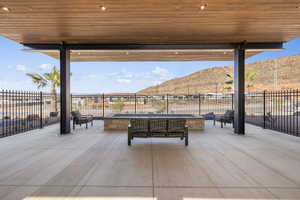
{"left": 0, "top": 36, "right": 300, "bottom": 93}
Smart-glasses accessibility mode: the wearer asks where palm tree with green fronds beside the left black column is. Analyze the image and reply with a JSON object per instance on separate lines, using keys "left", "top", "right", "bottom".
{"left": 26, "top": 66, "right": 60, "bottom": 113}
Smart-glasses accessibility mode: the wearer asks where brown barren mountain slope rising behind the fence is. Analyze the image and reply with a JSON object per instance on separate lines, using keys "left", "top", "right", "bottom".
{"left": 138, "top": 54, "right": 300, "bottom": 95}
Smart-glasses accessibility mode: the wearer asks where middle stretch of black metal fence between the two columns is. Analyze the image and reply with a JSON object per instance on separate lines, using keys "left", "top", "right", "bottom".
{"left": 71, "top": 94, "right": 233, "bottom": 118}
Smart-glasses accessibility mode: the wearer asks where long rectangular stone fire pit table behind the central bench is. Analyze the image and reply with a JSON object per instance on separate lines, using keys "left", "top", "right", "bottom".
{"left": 104, "top": 114, "right": 205, "bottom": 131}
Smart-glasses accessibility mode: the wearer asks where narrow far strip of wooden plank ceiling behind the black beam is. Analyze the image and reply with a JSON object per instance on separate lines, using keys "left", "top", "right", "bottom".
{"left": 25, "top": 50, "right": 261, "bottom": 62}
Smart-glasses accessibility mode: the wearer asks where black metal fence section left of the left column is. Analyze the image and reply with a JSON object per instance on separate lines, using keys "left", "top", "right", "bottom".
{"left": 0, "top": 90, "right": 59, "bottom": 137}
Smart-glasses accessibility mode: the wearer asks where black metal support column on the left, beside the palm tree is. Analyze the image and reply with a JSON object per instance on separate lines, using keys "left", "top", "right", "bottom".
{"left": 60, "top": 44, "right": 71, "bottom": 135}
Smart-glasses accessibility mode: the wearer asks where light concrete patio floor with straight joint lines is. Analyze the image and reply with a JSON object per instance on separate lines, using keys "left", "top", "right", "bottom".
{"left": 0, "top": 121, "right": 300, "bottom": 200}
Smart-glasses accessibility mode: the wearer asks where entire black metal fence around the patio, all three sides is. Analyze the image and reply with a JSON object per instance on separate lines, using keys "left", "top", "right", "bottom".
{"left": 0, "top": 90, "right": 300, "bottom": 137}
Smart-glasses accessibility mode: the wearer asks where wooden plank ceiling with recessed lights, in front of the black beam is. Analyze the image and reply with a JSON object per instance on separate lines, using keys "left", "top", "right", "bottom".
{"left": 0, "top": 0, "right": 300, "bottom": 61}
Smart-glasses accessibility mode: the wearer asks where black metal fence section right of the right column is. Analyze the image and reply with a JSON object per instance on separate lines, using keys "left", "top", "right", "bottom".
{"left": 246, "top": 90, "right": 300, "bottom": 136}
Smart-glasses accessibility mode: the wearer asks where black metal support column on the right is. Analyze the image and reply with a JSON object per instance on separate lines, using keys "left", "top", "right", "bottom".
{"left": 234, "top": 45, "right": 245, "bottom": 135}
